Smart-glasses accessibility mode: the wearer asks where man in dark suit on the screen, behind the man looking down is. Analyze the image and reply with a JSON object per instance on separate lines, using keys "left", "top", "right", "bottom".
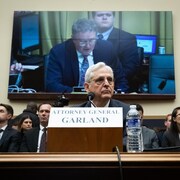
{"left": 92, "top": 11, "right": 141, "bottom": 92}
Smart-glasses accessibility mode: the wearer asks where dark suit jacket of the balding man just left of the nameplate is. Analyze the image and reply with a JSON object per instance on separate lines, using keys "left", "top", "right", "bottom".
{"left": 19, "top": 127, "right": 39, "bottom": 152}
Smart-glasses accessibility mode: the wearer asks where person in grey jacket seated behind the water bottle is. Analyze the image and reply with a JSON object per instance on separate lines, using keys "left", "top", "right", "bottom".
{"left": 123, "top": 104, "right": 159, "bottom": 151}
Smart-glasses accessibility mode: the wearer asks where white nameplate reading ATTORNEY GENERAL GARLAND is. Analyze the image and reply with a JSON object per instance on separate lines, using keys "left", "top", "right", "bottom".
{"left": 48, "top": 107, "right": 123, "bottom": 128}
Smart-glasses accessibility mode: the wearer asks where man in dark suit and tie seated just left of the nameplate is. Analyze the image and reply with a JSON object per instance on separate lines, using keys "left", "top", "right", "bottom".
{"left": 20, "top": 103, "right": 52, "bottom": 152}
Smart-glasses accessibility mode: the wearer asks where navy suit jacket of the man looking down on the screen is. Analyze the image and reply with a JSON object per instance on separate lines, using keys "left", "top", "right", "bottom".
{"left": 45, "top": 39, "right": 128, "bottom": 92}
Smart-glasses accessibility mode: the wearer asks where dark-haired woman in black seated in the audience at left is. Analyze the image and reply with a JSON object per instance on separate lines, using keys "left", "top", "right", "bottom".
{"left": 9, "top": 115, "right": 33, "bottom": 152}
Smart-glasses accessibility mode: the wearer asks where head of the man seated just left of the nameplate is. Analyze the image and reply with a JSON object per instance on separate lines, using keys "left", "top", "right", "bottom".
{"left": 38, "top": 103, "right": 52, "bottom": 127}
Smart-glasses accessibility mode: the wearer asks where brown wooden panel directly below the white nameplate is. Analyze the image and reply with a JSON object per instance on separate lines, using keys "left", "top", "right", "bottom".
{"left": 48, "top": 127, "right": 123, "bottom": 152}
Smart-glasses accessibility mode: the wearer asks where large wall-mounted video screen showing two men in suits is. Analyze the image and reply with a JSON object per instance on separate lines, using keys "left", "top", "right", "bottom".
{"left": 8, "top": 11, "right": 175, "bottom": 99}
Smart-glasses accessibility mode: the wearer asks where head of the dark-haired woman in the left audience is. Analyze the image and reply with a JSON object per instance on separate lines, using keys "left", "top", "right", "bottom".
{"left": 17, "top": 115, "right": 33, "bottom": 132}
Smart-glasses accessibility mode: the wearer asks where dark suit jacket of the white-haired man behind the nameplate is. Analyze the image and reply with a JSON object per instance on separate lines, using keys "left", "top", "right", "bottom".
{"left": 76, "top": 99, "right": 129, "bottom": 135}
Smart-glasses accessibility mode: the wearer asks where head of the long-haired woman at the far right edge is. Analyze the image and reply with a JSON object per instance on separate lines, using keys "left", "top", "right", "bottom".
{"left": 169, "top": 107, "right": 180, "bottom": 133}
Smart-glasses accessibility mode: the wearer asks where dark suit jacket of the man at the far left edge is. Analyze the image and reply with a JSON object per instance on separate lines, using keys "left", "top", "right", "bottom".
{"left": 0, "top": 126, "right": 18, "bottom": 152}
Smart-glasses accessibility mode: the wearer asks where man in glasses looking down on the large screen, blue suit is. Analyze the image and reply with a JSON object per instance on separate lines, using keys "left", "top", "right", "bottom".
{"left": 45, "top": 19, "right": 128, "bottom": 93}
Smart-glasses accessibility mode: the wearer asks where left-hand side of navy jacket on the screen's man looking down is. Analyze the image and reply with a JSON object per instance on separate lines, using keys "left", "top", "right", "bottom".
{"left": 45, "top": 42, "right": 75, "bottom": 93}
